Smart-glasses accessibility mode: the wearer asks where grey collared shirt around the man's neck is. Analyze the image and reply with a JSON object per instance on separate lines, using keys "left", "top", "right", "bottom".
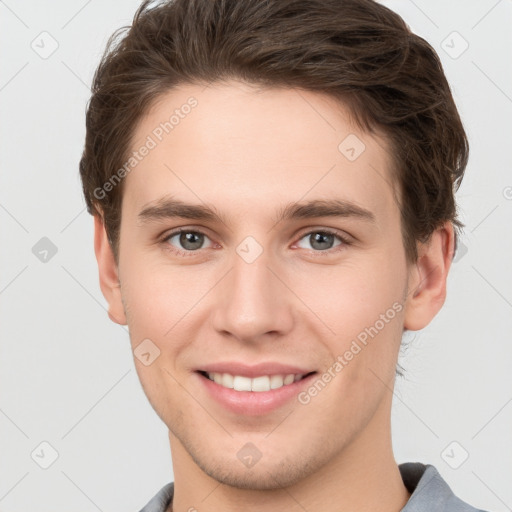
{"left": 140, "top": 462, "right": 485, "bottom": 512}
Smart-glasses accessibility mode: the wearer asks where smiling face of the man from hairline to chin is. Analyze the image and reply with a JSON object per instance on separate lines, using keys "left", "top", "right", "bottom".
{"left": 97, "top": 82, "right": 450, "bottom": 489}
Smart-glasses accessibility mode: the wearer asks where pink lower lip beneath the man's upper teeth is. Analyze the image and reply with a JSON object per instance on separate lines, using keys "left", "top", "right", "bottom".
{"left": 196, "top": 372, "right": 316, "bottom": 416}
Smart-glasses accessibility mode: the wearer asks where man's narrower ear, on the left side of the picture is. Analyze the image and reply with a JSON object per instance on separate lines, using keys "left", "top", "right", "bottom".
{"left": 94, "top": 215, "right": 127, "bottom": 325}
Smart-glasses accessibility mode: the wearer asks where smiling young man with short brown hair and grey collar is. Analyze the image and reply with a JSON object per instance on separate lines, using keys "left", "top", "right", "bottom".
{"left": 80, "top": 0, "right": 488, "bottom": 512}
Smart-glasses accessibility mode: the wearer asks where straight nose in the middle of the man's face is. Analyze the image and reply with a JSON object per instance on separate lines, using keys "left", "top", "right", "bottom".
{"left": 213, "top": 244, "right": 294, "bottom": 343}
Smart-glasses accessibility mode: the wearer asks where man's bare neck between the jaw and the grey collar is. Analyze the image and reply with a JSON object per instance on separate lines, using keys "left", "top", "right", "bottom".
{"left": 168, "top": 394, "right": 410, "bottom": 512}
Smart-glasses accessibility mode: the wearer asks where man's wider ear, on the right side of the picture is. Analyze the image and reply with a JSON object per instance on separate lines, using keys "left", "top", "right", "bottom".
{"left": 404, "top": 222, "right": 454, "bottom": 331}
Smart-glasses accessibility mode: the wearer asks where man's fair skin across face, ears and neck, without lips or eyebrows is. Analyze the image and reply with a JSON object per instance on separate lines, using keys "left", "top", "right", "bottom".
{"left": 95, "top": 81, "right": 453, "bottom": 512}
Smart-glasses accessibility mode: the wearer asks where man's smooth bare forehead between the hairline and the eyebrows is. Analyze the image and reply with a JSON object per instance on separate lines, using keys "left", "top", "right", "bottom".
{"left": 123, "top": 81, "right": 397, "bottom": 224}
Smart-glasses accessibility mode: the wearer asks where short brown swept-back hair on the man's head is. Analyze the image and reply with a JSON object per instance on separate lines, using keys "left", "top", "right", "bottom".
{"left": 80, "top": 0, "right": 468, "bottom": 262}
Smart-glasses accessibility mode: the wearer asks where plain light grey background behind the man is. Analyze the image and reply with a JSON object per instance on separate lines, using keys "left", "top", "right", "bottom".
{"left": 0, "top": 0, "right": 512, "bottom": 512}
